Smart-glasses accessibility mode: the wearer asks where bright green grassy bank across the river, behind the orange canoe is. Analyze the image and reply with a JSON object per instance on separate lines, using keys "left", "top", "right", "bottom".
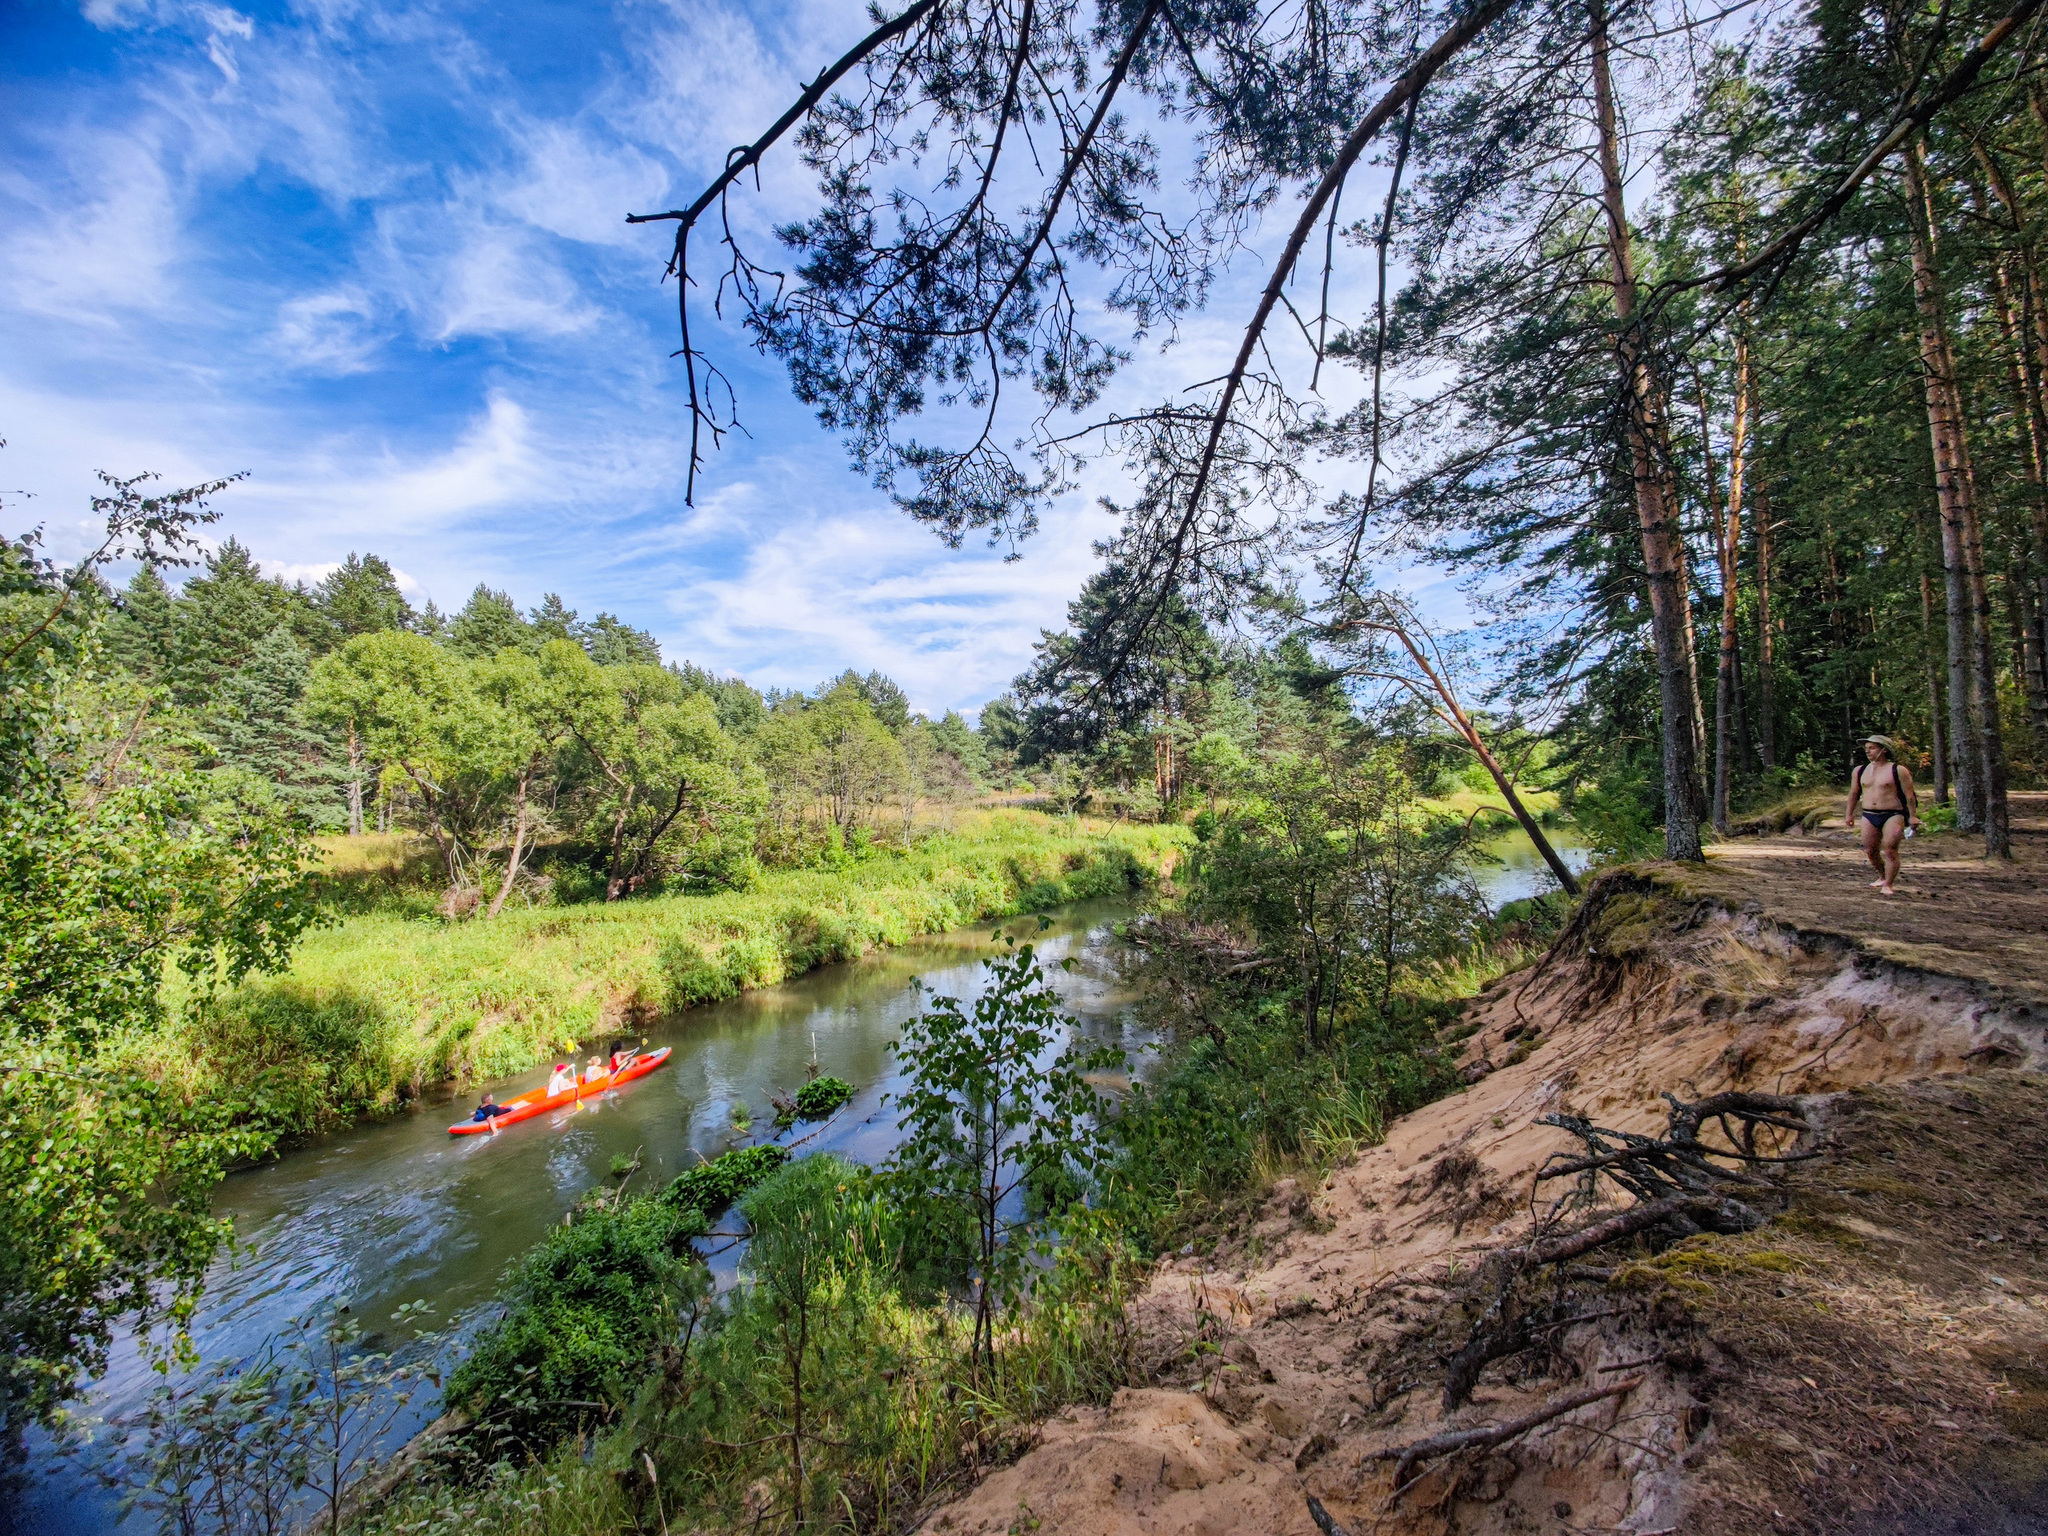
{"left": 123, "top": 811, "right": 1188, "bottom": 1135}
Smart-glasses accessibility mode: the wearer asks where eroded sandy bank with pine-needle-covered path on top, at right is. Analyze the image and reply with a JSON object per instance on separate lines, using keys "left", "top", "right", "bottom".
{"left": 926, "top": 843, "right": 2048, "bottom": 1536}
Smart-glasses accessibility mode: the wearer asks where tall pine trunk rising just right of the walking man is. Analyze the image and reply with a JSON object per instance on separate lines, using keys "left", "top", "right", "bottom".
{"left": 1905, "top": 141, "right": 2011, "bottom": 858}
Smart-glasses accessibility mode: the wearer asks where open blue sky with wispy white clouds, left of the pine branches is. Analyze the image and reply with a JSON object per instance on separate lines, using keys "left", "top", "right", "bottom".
{"left": 0, "top": 0, "right": 1482, "bottom": 711}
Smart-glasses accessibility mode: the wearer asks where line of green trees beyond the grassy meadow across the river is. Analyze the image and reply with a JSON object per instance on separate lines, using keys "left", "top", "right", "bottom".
{"left": 104, "top": 539, "right": 1008, "bottom": 915}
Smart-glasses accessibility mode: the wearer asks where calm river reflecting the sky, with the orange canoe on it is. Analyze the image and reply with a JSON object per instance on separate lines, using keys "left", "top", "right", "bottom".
{"left": 0, "top": 829, "right": 1585, "bottom": 1536}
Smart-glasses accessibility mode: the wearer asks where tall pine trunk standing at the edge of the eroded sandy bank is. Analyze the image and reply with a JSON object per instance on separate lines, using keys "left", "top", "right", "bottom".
{"left": 1591, "top": 0, "right": 1706, "bottom": 860}
